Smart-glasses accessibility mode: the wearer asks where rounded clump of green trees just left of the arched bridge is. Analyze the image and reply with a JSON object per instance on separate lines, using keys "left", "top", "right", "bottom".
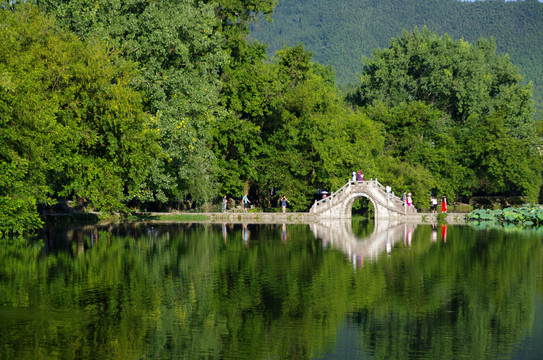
{"left": 215, "top": 46, "right": 384, "bottom": 210}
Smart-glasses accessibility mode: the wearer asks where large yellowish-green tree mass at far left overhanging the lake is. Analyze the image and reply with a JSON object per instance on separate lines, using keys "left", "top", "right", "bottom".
{"left": 0, "top": 5, "right": 157, "bottom": 236}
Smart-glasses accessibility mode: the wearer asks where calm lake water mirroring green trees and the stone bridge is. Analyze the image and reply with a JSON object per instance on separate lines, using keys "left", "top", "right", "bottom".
{"left": 0, "top": 222, "right": 543, "bottom": 359}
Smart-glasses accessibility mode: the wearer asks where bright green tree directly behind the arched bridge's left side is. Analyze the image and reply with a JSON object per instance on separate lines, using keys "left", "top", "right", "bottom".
{"left": 261, "top": 46, "right": 383, "bottom": 210}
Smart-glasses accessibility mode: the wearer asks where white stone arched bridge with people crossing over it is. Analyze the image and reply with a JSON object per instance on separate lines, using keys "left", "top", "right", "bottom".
{"left": 309, "top": 179, "right": 417, "bottom": 220}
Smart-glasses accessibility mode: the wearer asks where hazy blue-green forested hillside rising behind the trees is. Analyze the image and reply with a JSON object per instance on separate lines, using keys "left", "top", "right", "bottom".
{"left": 251, "top": 0, "right": 543, "bottom": 113}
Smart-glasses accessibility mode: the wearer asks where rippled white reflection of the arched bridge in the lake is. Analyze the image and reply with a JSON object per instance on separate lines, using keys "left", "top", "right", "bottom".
{"left": 310, "top": 220, "right": 417, "bottom": 266}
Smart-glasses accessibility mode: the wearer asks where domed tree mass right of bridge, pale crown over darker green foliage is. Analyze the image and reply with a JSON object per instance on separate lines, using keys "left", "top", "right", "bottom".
{"left": 351, "top": 28, "right": 541, "bottom": 201}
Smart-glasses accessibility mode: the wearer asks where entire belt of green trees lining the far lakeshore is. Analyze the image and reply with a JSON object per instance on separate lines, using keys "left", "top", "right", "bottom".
{"left": 0, "top": 0, "right": 541, "bottom": 230}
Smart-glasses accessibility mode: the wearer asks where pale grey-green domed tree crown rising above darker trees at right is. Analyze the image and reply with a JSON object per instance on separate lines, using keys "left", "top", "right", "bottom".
{"left": 353, "top": 27, "right": 534, "bottom": 129}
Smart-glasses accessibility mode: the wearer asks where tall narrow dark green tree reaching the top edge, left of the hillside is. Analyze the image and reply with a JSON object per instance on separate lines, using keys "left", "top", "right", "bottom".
{"left": 206, "top": 0, "right": 280, "bottom": 202}
